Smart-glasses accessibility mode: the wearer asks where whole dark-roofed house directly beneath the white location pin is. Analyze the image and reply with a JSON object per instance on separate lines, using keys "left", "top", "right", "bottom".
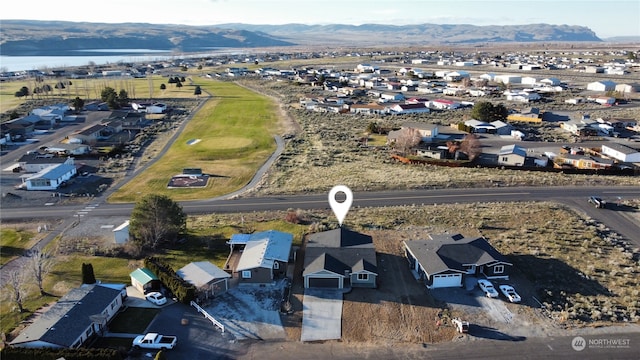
{"left": 302, "top": 227, "right": 378, "bottom": 289}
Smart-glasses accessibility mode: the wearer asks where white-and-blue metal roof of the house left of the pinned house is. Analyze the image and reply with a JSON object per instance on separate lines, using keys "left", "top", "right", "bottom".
{"left": 237, "top": 230, "right": 293, "bottom": 271}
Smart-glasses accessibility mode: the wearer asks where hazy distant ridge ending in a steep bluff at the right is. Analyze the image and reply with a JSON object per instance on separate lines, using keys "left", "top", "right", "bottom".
{"left": 218, "top": 23, "right": 602, "bottom": 45}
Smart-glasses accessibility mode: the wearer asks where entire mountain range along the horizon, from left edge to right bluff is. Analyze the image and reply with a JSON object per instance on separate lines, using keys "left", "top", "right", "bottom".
{"left": 0, "top": 20, "right": 602, "bottom": 56}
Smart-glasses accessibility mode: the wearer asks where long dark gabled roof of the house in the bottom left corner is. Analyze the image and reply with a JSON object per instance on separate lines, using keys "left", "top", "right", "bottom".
{"left": 11, "top": 284, "right": 125, "bottom": 347}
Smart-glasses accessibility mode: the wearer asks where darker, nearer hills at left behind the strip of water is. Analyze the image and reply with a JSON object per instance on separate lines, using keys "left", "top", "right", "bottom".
{"left": 0, "top": 20, "right": 294, "bottom": 56}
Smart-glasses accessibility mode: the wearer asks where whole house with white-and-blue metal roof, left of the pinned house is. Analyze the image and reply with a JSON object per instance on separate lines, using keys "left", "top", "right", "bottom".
{"left": 224, "top": 230, "right": 293, "bottom": 283}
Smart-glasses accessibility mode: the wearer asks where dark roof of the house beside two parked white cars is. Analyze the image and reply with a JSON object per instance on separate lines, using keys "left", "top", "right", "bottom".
{"left": 405, "top": 234, "right": 511, "bottom": 275}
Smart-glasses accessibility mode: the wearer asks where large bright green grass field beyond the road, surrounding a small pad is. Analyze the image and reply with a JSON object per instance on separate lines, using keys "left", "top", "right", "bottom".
{"left": 109, "top": 79, "right": 279, "bottom": 202}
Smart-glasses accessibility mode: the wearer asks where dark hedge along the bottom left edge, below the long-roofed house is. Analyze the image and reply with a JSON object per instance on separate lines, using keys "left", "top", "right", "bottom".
{"left": 0, "top": 347, "right": 124, "bottom": 360}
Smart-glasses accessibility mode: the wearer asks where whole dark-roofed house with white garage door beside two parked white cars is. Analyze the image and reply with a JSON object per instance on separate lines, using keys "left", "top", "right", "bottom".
{"left": 404, "top": 234, "right": 513, "bottom": 289}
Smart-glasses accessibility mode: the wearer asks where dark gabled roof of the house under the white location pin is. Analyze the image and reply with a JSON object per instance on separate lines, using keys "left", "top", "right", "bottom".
{"left": 303, "top": 227, "right": 378, "bottom": 276}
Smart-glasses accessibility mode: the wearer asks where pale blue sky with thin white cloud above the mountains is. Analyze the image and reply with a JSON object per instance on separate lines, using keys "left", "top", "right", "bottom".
{"left": 0, "top": 0, "right": 640, "bottom": 38}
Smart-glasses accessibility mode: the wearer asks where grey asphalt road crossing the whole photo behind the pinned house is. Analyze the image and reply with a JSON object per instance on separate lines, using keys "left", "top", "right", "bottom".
{"left": 0, "top": 187, "right": 640, "bottom": 246}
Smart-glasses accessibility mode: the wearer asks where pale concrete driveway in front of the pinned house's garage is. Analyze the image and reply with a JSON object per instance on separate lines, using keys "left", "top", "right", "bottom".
{"left": 300, "top": 289, "right": 342, "bottom": 341}
